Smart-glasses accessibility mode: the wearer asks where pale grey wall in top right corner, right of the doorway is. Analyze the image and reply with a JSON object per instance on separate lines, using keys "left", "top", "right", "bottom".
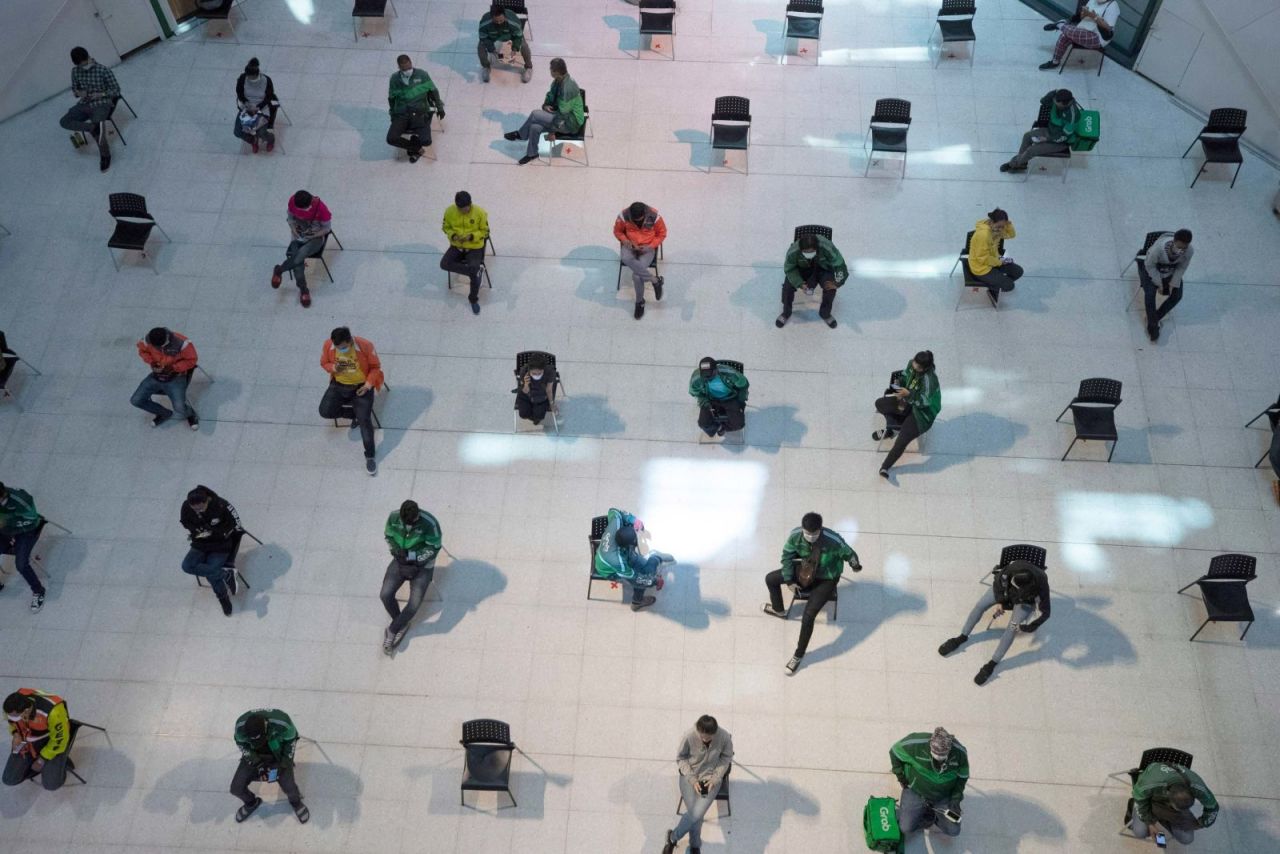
{"left": 1134, "top": 0, "right": 1280, "bottom": 160}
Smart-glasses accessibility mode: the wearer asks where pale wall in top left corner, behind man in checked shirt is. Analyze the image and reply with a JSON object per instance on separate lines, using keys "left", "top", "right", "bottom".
{"left": 0, "top": 0, "right": 120, "bottom": 119}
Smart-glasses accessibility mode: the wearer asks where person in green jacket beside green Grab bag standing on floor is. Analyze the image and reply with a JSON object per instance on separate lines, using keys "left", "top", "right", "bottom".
{"left": 888, "top": 726, "right": 969, "bottom": 836}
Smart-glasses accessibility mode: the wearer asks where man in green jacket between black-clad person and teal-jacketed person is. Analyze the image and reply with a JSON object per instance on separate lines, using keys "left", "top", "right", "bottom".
{"left": 379, "top": 501, "right": 443, "bottom": 656}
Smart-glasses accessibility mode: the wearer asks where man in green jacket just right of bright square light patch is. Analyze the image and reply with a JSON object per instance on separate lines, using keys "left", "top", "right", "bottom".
{"left": 763, "top": 512, "right": 863, "bottom": 676}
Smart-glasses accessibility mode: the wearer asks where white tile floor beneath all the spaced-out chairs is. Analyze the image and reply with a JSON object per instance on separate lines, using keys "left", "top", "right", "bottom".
{"left": 0, "top": 0, "right": 1280, "bottom": 854}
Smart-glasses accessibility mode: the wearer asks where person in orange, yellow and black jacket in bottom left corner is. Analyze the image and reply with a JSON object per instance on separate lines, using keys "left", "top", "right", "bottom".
{"left": 4, "top": 688, "right": 74, "bottom": 791}
